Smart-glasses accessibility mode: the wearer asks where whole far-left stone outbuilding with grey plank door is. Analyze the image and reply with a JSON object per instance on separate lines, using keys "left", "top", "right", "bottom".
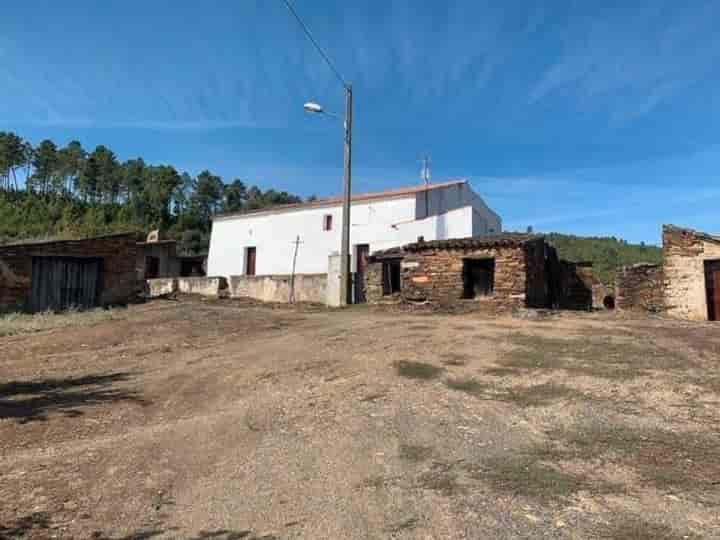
{"left": 0, "top": 234, "right": 139, "bottom": 312}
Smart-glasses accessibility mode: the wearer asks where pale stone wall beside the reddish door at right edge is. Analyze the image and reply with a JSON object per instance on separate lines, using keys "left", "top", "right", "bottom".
{"left": 663, "top": 225, "right": 720, "bottom": 321}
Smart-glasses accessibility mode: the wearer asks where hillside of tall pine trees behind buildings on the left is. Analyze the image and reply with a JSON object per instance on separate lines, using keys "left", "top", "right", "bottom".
{"left": 0, "top": 132, "right": 300, "bottom": 252}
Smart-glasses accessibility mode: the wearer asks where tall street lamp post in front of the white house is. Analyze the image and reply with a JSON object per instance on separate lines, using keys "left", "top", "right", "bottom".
{"left": 305, "top": 84, "right": 353, "bottom": 306}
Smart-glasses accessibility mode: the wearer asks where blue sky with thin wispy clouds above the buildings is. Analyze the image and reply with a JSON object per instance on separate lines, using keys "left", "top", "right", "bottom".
{"left": 0, "top": 0, "right": 720, "bottom": 243}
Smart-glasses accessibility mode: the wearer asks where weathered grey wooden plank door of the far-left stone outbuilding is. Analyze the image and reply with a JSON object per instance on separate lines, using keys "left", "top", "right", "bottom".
{"left": 29, "top": 257, "right": 102, "bottom": 312}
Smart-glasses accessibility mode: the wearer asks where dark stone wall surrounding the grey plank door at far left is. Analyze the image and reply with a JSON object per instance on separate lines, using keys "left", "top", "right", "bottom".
{"left": 0, "top": 234, "right": 140, "bottom": 310}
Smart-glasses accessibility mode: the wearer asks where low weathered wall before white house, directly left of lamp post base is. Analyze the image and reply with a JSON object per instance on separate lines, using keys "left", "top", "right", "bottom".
{"left": 228, "top": 274, "right": 327, "bottom": 304}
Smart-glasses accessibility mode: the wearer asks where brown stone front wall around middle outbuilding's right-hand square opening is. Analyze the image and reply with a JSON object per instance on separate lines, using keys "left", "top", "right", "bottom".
{"left": 401, "top": 246, "right": 527, "bottom": 310}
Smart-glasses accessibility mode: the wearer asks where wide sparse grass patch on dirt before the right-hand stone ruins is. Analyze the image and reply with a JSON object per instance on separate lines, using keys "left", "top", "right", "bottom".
{"left": 501, "top": 334, "right": 692, "bottom": 380}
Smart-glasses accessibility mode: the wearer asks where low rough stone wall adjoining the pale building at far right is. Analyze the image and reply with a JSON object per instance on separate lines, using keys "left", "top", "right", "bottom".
{"left": 615, "top": 264, "right": 664, "bottom": 313}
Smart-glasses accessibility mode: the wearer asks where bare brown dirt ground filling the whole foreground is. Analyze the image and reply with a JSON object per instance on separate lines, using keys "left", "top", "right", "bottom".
{"left": 0, "top": 299, "right": 720, "bottom": 540}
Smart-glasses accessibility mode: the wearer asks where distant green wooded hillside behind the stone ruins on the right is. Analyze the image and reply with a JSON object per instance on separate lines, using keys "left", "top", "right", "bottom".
{"left": 545, "top": 233, "right": 662, "bottom": 285}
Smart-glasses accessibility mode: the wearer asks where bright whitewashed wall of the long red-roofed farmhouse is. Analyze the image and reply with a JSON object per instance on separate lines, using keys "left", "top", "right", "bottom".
{"left": 208, "top": 195, "right": 474, "bottom": 277}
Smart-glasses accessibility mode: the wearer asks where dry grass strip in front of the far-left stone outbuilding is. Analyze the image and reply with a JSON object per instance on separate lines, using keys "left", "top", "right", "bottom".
{"left": 0, "top": 309, "right": 126, "bottom": 337}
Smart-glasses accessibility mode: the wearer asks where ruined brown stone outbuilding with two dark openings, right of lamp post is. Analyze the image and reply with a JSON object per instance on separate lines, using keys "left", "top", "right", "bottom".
{"left": 364, "top": 233, "right": 592, "bottom": 311}
